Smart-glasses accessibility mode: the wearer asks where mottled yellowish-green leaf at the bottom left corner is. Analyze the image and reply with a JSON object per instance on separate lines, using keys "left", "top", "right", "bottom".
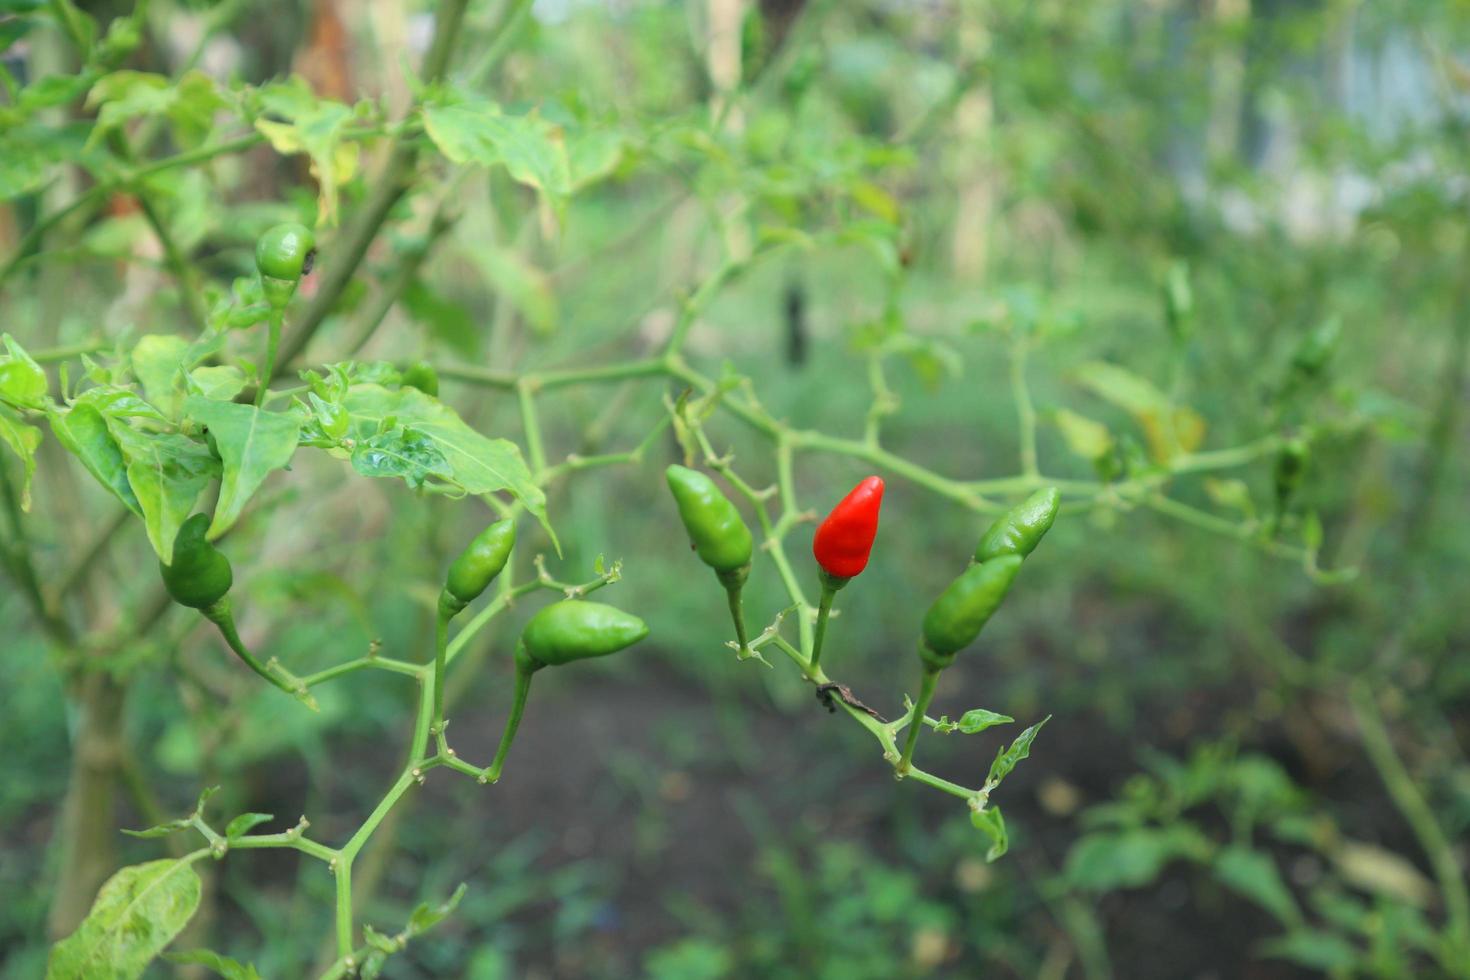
{"left": 46, "top": 860, "right": 200, "bottom": 980}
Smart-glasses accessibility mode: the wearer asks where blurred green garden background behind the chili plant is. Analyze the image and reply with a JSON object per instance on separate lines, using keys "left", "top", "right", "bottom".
{"left": 0, "top": 0, "right": 1470, "bottom": 980}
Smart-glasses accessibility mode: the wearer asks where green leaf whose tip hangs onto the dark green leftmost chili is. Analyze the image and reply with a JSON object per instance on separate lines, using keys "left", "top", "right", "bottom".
{"left": 107, "top": 419, "right": 219, "bottom": 561}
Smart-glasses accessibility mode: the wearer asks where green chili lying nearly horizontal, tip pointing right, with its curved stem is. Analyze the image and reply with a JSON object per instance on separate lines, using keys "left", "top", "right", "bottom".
{"left": 484, "top": 599, "right": 648, "bottom": 783}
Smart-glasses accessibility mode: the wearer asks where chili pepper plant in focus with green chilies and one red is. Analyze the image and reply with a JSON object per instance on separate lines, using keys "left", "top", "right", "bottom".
{"left": 0, "top": 0, "right": 1336, "bottom": 979}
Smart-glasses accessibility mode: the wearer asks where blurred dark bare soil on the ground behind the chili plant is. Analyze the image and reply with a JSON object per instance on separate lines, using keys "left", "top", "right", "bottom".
{"left": 213, "top": 646, "right": 1416, "bottom": 980}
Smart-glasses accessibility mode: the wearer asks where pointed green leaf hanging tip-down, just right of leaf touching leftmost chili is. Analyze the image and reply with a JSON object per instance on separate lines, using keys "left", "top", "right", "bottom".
{"left": 184, "top": 395, "right": 301, "bottom": 539}
